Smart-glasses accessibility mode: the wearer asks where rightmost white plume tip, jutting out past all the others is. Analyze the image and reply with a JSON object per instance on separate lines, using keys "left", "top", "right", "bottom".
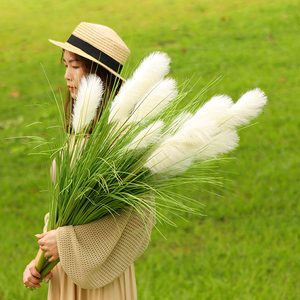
{"left": 224, "top": 88, "right": 267, "bottom": 128}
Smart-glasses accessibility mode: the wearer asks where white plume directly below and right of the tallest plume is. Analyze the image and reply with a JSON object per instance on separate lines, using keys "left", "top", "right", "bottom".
{"left": 128, "top": 78, "right": 178, "bottom": 123}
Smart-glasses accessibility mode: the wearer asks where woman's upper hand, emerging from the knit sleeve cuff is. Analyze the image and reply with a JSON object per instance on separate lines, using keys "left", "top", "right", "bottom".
{"left": 36, "top": 229, "right": 59, "bottom": 261}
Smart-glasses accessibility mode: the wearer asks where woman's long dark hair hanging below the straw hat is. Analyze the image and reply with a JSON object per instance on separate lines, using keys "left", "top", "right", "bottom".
{"left": 62, "top": 51, "right": 122, "bottom": 133}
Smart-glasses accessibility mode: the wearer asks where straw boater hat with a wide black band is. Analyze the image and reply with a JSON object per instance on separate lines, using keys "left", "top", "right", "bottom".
{"left": 49, "top": 22, "right": 130, "bottom": 80}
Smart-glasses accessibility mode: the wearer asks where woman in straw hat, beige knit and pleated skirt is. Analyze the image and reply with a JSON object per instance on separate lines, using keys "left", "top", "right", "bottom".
{"left": 23, "top": 23, "right": 155, "bottom": 300}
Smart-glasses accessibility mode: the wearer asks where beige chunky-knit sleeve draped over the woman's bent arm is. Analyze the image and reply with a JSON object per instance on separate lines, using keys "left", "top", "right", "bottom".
{"left": 57, "top": 203, "right": 155, "bottom": 289}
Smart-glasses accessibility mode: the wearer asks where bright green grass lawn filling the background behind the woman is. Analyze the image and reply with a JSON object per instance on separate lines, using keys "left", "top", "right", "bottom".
{"left": 0, "top": 0, "right": 300, "bottom": 300}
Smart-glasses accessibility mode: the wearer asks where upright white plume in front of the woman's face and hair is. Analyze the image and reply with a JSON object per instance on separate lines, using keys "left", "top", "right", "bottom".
{"left": 72, "top": 74, "right": 103, "bottom": 133}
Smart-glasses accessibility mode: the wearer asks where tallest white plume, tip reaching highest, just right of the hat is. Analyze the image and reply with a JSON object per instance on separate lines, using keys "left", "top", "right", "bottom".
{"left": 108, "top": 52, "right": 171, "bottom": 122}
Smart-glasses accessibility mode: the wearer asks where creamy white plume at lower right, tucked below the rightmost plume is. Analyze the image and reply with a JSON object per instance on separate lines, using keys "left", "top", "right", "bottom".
{"left": 196, "top": 130, "right": 239, "bottom": 160}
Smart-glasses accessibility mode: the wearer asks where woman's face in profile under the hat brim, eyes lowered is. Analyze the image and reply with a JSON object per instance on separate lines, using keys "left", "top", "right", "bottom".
{"left": 63, "top": 50, "right": 87, "bottom": 99}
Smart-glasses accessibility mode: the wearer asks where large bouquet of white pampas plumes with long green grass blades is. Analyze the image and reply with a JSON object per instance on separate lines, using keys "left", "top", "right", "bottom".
{"left": 33, "top": 52, "right": 267, "bottom": 284}
